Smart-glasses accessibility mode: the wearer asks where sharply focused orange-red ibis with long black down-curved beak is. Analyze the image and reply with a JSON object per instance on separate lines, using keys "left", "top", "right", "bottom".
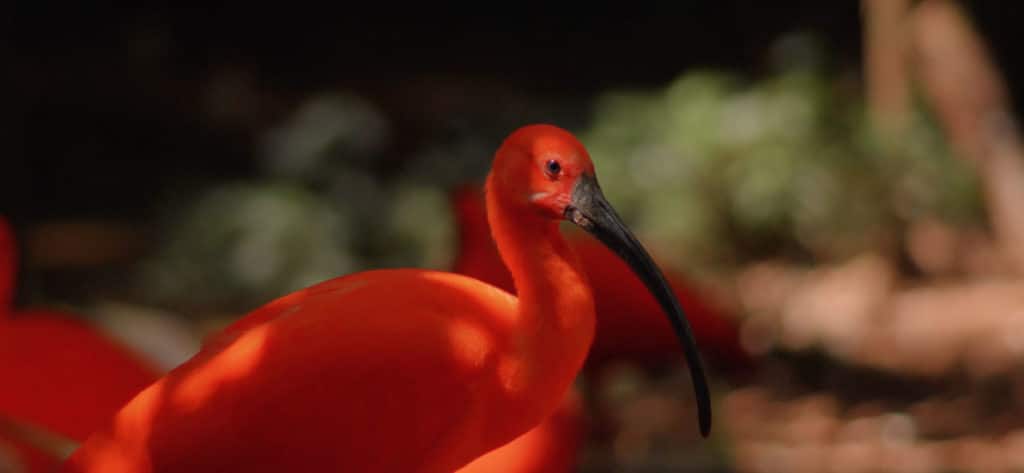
{"left": 65, "top": 125, "right": 712, "bottom": 473}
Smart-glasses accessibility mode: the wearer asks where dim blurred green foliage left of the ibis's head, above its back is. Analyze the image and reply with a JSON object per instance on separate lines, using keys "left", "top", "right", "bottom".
{"left": 140, "top": 93, "right": 455, "bottom": 311}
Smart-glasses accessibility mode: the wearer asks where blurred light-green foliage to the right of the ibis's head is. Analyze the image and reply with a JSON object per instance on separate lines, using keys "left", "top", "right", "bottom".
{"left": 580, "top": 53, "right": 982, "bottom": 269}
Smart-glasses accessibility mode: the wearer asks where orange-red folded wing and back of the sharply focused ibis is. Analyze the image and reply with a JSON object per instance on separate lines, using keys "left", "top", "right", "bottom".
{"left": 71, "top": 269, "right": 515, "bottom": 472}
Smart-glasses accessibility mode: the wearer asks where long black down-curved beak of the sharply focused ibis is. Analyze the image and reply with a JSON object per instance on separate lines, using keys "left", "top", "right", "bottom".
{"left": 565, "top": 175, "right": 711, "bottom": 437}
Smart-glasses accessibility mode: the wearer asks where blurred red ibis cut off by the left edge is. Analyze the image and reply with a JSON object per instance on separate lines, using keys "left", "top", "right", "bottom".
{"left": 0, "top": 218, "right": 160, "bottom": 472}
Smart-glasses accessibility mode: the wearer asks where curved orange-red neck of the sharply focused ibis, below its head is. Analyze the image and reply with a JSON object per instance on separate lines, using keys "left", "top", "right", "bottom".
{"left": 486, "top": 176, "right": 595, "bottom": 409}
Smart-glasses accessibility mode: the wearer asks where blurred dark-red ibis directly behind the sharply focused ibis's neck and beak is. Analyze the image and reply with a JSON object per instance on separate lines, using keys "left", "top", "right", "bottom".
{"left": 451, "top": 183, "right": 752, "bottom": 369}
